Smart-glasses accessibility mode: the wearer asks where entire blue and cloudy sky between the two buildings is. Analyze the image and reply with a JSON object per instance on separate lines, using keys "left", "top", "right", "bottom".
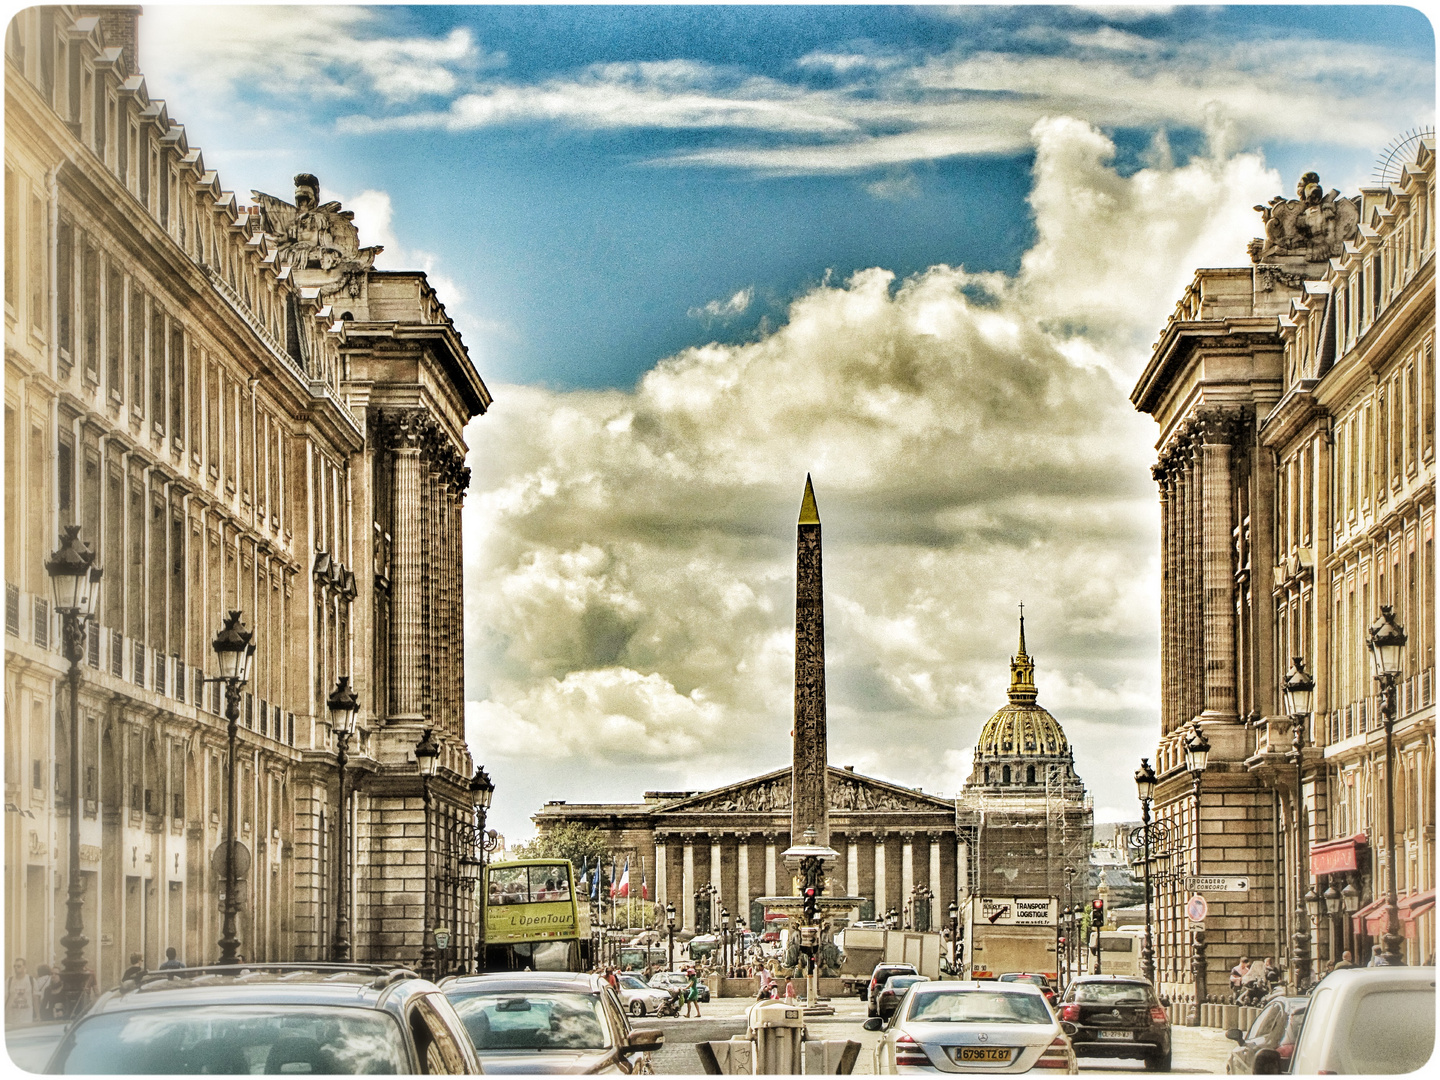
{"left": 129, "top": 4, "right": 1436, "bottom": 842}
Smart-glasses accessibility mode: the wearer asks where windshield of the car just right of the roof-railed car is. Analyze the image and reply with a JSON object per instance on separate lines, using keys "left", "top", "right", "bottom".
{"left": 446, "top": 991, "right": 613, "bottom": 1053}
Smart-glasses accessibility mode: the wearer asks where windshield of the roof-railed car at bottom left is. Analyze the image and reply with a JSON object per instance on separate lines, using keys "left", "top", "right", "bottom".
{"left": 52, "top": 1005, "right": 412, "bottom": 1074}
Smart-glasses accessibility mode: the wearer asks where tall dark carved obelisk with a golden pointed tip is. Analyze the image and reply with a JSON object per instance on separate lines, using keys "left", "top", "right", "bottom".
{"left": 791, "top": 474, "right": 829, "bottom": 848}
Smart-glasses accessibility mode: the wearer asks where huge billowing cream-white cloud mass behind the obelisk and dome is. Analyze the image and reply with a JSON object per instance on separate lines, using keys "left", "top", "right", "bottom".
{"left": 465, "top": 117, "right": 1279, "bottom": 823}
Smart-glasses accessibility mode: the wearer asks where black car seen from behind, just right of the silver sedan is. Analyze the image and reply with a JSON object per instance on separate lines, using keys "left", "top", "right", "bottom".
{"left": 1058, "top": 975, "right": 1171, "bottom": 1073}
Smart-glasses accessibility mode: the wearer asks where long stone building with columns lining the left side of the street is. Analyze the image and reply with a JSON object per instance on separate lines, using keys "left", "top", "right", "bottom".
{"left": 4, "top": 6, "right": 490, "bottom": 985}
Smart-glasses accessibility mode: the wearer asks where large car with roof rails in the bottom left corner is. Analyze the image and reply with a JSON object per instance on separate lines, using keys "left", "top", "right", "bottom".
{"left": 46, "top": 963, "right": 480, "bottom": 1074}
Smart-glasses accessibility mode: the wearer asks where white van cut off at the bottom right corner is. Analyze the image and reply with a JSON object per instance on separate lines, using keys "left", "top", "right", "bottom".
{"left": 1278, "top": 966, "right": 1436, "bottom": 1074}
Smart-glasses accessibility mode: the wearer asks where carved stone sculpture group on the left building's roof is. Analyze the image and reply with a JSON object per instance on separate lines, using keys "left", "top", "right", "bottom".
{"left": 251, "top": 173, "right": 384, "bottom": 297}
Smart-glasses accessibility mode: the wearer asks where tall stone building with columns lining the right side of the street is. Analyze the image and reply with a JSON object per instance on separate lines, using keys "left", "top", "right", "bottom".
{"left": 1132, "top": 144, "right": 1434, "bottom": 999}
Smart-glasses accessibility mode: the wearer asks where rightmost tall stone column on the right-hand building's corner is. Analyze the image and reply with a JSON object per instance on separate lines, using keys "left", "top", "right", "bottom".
{"left": 1201, "top": 412, "right": 1238, "bottom": 717}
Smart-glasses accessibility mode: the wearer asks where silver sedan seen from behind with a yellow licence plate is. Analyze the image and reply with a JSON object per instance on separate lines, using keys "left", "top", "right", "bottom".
{"left": 865, "top": 981, "right": 1077, "bottom": 1073}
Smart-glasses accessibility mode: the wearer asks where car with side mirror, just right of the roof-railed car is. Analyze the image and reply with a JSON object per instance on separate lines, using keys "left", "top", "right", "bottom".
{"left": 441, "top": 972, "right": 665, "bottom": 1074}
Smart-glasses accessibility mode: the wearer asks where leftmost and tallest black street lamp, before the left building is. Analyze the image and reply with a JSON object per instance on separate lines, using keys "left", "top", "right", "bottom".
{"left": 45, "top": 529, "right": 101, "bottom": 1017}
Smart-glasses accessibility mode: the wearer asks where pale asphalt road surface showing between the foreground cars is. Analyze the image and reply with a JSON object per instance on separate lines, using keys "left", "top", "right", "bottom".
{"left": 634, "top": 998, "right": 1234, "bottom": 1076}
